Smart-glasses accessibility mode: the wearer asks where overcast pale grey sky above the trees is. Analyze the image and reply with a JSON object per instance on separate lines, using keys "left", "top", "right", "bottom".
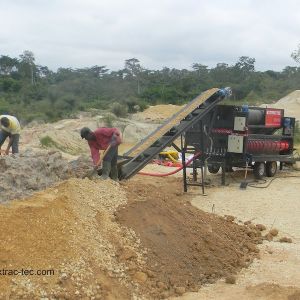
{"left": 0, "top": 0, "right": 300, "bottom": 71}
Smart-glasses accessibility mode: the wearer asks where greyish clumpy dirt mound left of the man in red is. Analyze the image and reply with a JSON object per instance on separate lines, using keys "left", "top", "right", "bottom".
{"left": 0, "top": 150, "right": 92, "bottom": 203}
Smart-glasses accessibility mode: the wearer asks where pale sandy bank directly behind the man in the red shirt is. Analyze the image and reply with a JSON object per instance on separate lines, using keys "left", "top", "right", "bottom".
{"left": 20, "top": 115, "right": 158, "bottom": 160}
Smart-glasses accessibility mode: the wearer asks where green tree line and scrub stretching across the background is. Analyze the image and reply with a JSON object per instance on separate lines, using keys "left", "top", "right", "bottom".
{"left": 0, "top": 49, "right": 300, "bottom": 122}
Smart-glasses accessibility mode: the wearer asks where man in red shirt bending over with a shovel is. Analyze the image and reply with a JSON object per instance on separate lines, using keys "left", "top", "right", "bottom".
{"left": 80, "top": 127, "right": 122, "bottom": 181}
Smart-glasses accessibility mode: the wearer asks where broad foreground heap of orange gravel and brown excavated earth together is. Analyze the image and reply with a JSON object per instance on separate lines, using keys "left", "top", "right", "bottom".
{"left": 0, "top": 165, "right": 262, "bottom": 299}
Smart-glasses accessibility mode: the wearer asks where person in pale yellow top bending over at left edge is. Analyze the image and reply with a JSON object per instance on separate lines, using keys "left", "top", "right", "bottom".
{"left": 0, "top": 115, "right": 21, "bottom": 155}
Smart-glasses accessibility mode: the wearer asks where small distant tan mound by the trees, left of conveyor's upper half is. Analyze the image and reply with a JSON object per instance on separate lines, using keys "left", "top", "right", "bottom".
{"left": 133, "top": 104, "right": 182, "bottom": 123}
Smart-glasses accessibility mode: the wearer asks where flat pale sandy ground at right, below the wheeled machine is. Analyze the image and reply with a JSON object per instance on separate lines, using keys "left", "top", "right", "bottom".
{"left": 172, "top": 171, "right": 300, "bottom": 300}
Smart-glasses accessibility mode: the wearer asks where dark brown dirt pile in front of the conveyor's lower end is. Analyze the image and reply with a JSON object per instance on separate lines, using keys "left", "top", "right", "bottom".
{"left": 117, "top": 178, "right": 261, "bottom": 298}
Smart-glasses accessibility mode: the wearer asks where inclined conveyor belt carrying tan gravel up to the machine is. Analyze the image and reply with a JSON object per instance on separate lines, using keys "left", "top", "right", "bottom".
{"left": 121, "top": 88, "right": 229, "bottom": 179}
